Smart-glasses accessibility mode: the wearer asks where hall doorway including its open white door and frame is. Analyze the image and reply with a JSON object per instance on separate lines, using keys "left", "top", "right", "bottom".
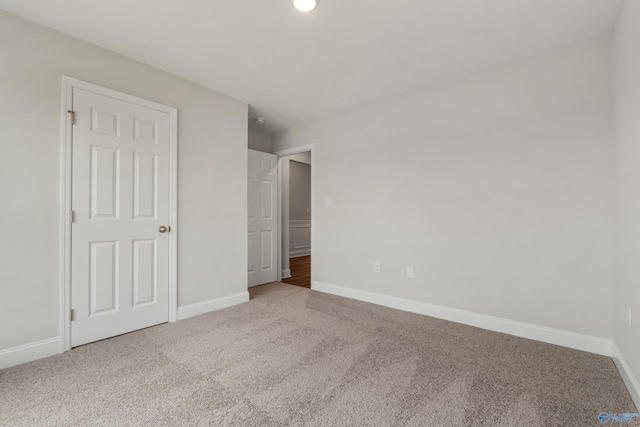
{"left": 248, "top": 145, "right": 314, "bottom": 292}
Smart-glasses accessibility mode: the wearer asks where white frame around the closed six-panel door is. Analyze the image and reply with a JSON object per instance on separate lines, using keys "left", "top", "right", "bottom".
{"left": 59, "top": 76, "right": 178, "bottom": 353}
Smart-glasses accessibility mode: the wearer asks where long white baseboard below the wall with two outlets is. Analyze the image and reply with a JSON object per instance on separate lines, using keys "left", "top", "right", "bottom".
{"left": 311, "top": 282, "right": 612, "bottom": 357}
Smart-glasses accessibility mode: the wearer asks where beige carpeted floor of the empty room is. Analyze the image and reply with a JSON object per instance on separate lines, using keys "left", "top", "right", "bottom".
{"left": 0, "top": 283, "right": 636, "bottom": 426}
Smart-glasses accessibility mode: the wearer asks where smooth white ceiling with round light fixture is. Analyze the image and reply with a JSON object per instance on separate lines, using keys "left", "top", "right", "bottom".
{"left": 0, "top": 0, "right": 622, "bottom": 133}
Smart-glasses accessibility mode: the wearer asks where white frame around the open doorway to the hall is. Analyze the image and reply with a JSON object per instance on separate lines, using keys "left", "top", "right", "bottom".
{"left": 273, "top": 144, "right": 316, "bottom": 289}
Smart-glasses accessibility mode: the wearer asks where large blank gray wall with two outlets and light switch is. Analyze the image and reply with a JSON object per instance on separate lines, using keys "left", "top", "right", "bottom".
{"left": 272, "top": 37, "right": 614, "bottom": 338}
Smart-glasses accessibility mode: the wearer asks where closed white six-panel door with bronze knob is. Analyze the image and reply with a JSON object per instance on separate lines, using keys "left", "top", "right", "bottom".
{"left": 71, "top": 88, "right": 170, "bottom": 347}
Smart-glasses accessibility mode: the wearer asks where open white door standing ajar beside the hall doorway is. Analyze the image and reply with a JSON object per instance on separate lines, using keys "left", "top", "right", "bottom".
{"left": 248, "top": 150, "right": 278, "bottom": 287}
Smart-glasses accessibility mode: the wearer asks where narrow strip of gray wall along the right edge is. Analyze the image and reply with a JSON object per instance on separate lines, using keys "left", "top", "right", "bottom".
{"left": 613, "top": 1, "right": 640, "bottom": 394}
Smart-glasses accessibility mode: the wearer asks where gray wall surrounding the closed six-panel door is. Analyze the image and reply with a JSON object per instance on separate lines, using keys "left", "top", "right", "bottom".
{"left": 0, "top": 12, "right": 248, "bottom": 350}
